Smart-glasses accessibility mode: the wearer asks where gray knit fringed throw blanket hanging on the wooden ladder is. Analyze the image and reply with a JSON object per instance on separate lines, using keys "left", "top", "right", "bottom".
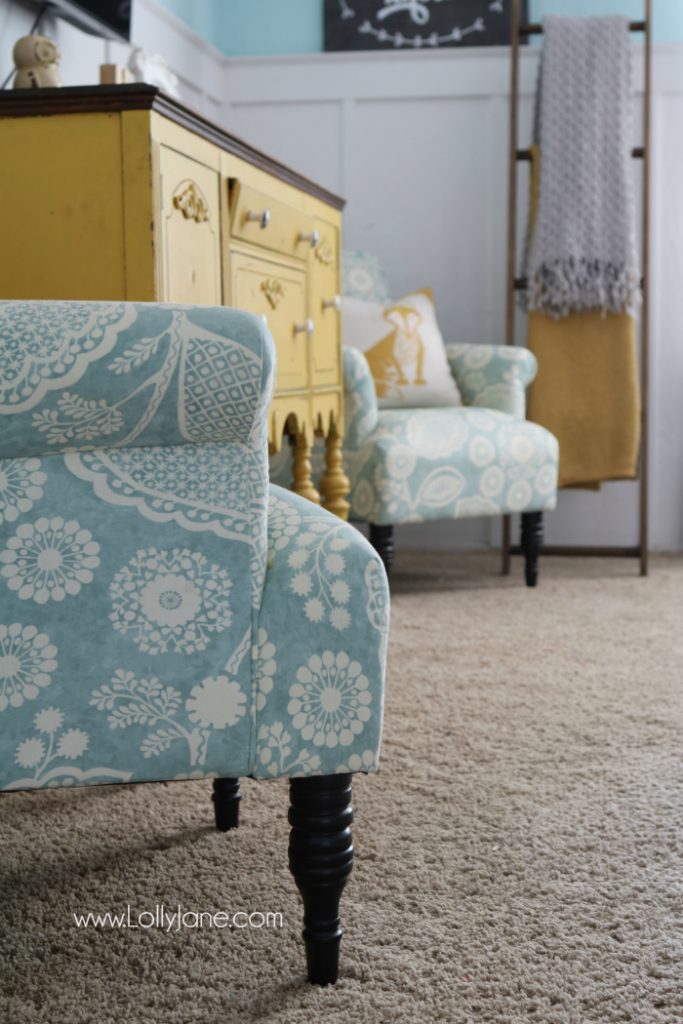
{"left": 525, "top": 16, "right": 640, "bottom": 318}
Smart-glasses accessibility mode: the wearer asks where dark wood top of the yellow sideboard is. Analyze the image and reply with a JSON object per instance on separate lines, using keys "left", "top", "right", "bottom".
{"left": 0, "top": 83, "right": 345, "bottom": 210}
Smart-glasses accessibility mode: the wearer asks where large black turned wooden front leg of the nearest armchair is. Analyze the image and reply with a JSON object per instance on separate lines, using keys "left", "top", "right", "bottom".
{"left": 289, "top": 775, "right": 353, "bottom": 985}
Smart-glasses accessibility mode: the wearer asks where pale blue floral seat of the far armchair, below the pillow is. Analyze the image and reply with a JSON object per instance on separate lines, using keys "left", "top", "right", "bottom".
{"left": 345, "top": 407, "right": 559, "bottom": 525}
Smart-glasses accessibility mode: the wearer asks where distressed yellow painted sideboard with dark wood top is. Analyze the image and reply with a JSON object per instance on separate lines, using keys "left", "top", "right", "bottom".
{"left": 0, "top": 85, "right": 349, "bottom": 517}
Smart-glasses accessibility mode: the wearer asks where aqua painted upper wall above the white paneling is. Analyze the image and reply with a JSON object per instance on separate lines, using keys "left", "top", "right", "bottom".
{"left": 158, "top": 0, "right": 683, "bottom": 56}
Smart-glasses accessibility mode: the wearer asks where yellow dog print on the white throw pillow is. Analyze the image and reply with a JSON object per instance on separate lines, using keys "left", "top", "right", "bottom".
{"left": 366, "top": 306, "right": 427, "bottom": 398}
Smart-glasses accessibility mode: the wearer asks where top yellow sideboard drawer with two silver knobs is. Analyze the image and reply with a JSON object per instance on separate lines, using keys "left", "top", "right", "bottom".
{"left": 230, "top": 180, "right": 313, "bottom": 260}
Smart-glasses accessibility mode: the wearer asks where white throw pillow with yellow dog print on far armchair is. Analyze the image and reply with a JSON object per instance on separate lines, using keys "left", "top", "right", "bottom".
{"left": 342, "top": 289, "right": 462, "bottom": 409}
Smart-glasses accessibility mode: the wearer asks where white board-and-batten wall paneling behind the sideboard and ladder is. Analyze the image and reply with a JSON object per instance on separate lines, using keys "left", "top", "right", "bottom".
{"left": 0, "top": 0, "right": 683, "bottom": 550}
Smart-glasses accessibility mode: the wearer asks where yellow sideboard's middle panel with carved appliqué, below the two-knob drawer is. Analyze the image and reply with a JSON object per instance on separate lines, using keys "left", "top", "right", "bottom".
{"left": 230, "top": 251, "right": 311, "bottom": 392}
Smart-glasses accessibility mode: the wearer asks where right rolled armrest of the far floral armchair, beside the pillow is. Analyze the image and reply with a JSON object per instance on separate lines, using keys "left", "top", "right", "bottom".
{"left": 445, "top": 345, "right": 538, "bottom": 420}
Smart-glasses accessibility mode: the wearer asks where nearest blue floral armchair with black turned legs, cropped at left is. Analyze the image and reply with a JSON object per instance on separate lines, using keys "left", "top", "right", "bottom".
{"left": 0, "top": 302, "right": 388, "bottom": 983}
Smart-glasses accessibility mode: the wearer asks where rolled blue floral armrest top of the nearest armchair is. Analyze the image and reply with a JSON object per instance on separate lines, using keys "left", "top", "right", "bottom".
{"left": 0, "top": 301, "right": 274, "bottom": 463}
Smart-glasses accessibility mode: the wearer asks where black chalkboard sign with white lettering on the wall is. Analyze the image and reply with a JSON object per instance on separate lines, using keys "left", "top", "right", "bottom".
{"left": 325, "top": 0, "right": 526, "bottom": 50}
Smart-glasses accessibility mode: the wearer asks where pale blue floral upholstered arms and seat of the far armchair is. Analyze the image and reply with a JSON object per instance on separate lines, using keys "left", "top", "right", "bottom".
{"left": 271, "top": 345, "right": 559, "bottom": 525}
